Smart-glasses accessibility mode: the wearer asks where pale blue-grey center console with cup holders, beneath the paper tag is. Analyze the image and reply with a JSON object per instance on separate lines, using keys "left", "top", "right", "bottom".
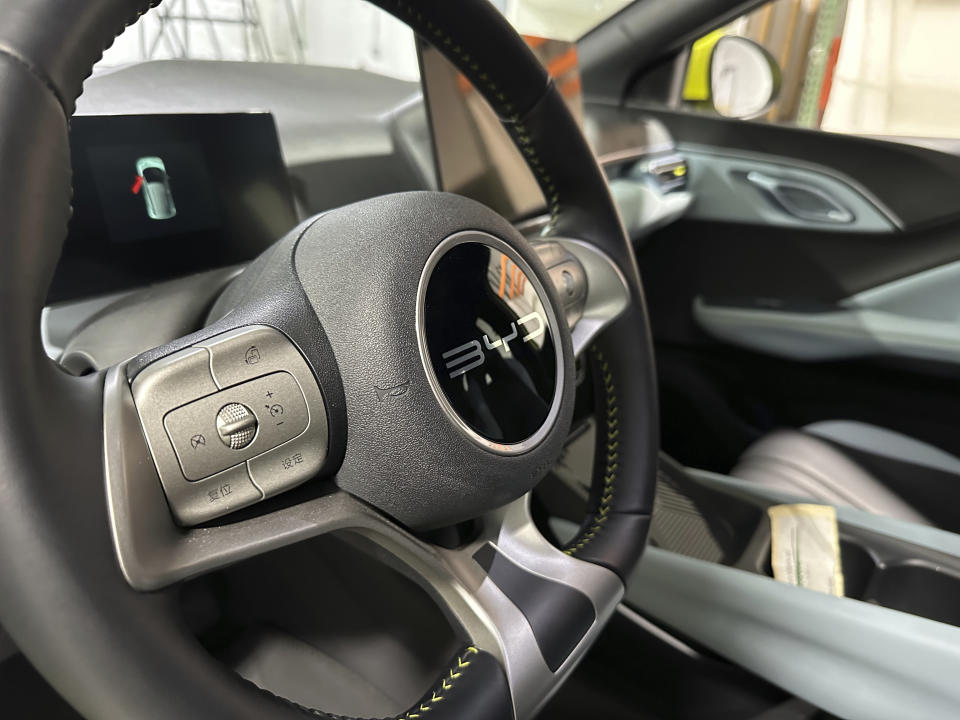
{"left": 626, "top": 458, "right": 960, "bottom": 719}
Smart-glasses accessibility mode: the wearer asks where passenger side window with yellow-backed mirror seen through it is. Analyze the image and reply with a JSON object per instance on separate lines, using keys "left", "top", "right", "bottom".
{"left": 675, "top": 0, "right": 960, "bottom": 138}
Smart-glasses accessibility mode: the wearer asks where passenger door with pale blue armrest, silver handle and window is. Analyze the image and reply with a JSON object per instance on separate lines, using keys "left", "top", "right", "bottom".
{"left": 581, "top": 0, "right": 960, "bottom": 524}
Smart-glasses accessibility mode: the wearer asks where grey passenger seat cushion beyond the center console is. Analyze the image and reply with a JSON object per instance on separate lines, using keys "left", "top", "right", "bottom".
{"left": 730, "top": 420, "right": 960, "bottom": 532}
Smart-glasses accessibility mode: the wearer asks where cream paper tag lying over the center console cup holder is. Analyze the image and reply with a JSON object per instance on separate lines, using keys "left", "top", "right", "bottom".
{"left": 767, "top": 504, "right": 843, "bottom": 597}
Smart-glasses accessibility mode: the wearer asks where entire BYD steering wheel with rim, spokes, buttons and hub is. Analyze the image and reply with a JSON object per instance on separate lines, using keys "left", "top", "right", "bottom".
{"left": 0, "top": 0, "right": 657, "bottom": 720}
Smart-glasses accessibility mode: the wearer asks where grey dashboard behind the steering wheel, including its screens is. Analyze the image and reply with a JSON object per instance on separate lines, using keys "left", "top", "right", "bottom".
{"left": 42, "top": 54, "right": 690, "bottom": 372}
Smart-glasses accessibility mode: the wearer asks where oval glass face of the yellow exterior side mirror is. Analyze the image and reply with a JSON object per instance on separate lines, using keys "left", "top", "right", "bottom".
{"left": 710, "top": 35, "right": 780, "bottom": 120}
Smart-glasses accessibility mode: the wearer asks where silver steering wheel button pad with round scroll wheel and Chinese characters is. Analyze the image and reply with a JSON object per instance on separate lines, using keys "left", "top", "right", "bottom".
{"left": 131, "top": 326, "right": 327, "bottom": 525}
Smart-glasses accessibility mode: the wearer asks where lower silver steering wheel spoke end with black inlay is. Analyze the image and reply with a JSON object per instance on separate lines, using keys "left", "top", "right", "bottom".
{"left": 426, "top": 495, "right": 623, "bottom": 717}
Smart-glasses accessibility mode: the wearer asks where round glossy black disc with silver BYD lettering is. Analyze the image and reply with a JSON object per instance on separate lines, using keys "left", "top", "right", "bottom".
{"left": 421, "top": 241, "right": 559, "bottom": 445}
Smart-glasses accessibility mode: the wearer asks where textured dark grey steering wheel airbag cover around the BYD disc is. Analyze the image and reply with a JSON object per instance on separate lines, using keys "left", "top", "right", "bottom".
{"left": 212, "top": 192, "right": 574, "bottom": 529}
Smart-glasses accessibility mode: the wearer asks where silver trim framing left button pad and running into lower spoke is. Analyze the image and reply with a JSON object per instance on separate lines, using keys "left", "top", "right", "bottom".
{"left": 104, "top": 342, "right": 623, "bottom": 717}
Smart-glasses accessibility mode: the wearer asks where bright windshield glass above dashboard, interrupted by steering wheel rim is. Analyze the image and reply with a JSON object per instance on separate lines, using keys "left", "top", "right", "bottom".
{"left": 95, "top": 0, "right": 632, "bottom": 80}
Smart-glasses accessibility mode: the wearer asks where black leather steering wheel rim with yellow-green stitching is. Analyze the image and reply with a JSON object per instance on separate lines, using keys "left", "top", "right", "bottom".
{"left": 0, "top": 0, "right": 658, "bottom": 718}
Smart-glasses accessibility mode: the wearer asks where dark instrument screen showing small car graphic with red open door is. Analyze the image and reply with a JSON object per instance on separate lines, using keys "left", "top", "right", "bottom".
{"left": 48, "top": 113, "right": 297, "bottom": 303}
